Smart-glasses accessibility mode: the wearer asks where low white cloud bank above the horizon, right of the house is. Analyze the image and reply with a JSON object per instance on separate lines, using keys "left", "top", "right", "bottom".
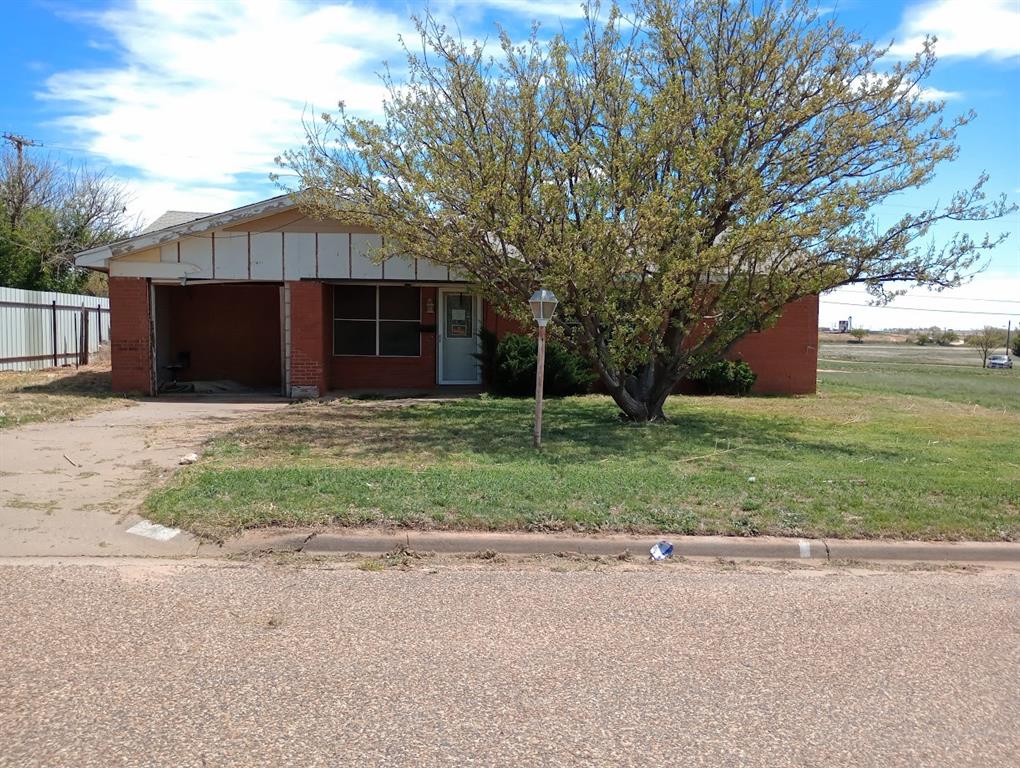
{"left": 818, "top": 267, "right": 1020, "bottom": 330}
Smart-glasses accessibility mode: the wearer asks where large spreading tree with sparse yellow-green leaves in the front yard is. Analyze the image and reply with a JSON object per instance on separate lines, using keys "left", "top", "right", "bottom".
{"left": 281, "top": 0, "right": 1011, "bottom": 420}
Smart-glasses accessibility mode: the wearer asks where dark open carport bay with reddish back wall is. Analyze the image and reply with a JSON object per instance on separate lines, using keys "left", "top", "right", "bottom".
{"left": 153, "top": 283, "right": 283, "bottom": 394}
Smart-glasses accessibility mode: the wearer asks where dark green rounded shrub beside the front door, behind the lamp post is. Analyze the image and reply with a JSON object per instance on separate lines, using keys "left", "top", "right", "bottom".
{"left": 479, "top": 334, "right": 595, "bottom": 397}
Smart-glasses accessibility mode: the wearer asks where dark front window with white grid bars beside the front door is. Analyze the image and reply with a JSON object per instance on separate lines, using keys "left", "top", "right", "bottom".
{"left": 333, "top": 286, "right": 421, "bottom": 357}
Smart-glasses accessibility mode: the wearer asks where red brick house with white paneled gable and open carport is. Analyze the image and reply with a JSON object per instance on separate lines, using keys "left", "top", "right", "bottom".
{"left": 77, "top": 195, "right": 818, "bottom": 397}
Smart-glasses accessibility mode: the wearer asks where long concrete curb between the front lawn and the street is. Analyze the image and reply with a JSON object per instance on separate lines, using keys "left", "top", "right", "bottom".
{"left": 221, "top": 529, "right": 1020, "bottom": 565}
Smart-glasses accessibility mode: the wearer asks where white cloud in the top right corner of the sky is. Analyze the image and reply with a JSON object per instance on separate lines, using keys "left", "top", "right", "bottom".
{"left": 890, "top": 0, "right": 1020, "bottom": 59}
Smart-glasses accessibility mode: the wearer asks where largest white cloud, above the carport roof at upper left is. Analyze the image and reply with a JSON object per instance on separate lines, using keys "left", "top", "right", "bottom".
{"left": 40, "top": 0, "right": 412, "bottom": 218}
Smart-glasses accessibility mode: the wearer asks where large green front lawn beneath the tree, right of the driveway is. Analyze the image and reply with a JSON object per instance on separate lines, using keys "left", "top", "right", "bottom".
{"left": 147, "top": 370, "right": 1020, "bottom": 540}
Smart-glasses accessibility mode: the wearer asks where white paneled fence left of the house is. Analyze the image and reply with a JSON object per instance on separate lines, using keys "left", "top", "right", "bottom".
{"left": 0, "top": 288, "right": 110, "bottom": 370}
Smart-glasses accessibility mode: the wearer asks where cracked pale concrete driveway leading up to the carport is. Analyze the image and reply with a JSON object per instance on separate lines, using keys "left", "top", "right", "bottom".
{"left": 0, "top": 397, "right": 287, "bottom": 556}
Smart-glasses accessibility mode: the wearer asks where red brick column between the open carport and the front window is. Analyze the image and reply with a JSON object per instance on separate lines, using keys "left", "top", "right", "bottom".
{"left": 287, "top": 280, "right": 333, "bottom": 398}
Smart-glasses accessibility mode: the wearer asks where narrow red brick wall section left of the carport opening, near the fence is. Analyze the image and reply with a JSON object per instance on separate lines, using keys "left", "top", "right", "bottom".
{"left": 109, "top": 277, "right": 153, "bottom": 395}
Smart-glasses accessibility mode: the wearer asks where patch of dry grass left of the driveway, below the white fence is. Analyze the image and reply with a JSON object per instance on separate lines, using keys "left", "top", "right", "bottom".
{"left": 0, "top": 363, "right": 132, "bottom": 429}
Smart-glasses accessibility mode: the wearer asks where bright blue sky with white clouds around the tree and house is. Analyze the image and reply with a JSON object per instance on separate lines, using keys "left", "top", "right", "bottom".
{"left": 0, "top": 0, "right": 1020, "bottom": 328}
